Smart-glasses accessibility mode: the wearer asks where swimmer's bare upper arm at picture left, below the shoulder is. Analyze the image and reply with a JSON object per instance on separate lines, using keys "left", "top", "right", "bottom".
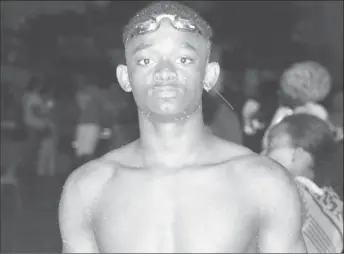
{"left": 59, "top": 168, "right": 99, "bottom": 253}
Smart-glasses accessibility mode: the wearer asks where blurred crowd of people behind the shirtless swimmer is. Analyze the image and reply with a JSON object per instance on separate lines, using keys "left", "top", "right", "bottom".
{"left": 1, "top": 50, "right": 343, "bottom": 252}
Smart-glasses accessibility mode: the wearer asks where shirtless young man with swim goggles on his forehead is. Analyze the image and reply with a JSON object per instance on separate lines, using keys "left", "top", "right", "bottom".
{"left": 59, "top": 2, "right": 305, "bottom": 253}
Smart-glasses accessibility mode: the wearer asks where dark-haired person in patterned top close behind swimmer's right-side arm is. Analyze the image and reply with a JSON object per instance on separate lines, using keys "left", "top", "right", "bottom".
{"left": 262, "top": 114, "right": 343, "bottom": 253}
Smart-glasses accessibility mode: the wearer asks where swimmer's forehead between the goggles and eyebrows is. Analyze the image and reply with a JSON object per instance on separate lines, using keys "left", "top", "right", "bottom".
{"left": 126, "top": 19, "right": 209, "bottom": 53}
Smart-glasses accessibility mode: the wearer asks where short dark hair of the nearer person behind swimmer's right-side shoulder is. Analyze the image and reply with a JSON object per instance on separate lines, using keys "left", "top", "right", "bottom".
{"left": 267, "top": 114, "right": 336, "bottom": 186}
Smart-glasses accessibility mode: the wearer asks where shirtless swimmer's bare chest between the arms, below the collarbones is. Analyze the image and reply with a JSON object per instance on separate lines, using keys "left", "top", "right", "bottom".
{"left": 83, "top": 138, "right": 259, "bottom": 253}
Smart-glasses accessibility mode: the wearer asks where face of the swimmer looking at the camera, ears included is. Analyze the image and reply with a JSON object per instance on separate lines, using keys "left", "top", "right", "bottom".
{"left": 117, "top": 18, "right": 220, "bottom": 121}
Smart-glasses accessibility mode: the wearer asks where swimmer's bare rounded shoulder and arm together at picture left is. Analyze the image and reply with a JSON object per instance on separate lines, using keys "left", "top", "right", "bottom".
{"left": 58, "top": 159, "right": 115, "bottom": 253}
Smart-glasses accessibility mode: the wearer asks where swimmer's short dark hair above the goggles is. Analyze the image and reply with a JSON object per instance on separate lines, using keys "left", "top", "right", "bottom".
{"left": 122, "top": 1, "right": 213, "bottom": 45}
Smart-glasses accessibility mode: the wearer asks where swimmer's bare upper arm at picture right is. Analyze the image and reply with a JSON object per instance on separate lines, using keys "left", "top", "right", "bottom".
{"left": 255, "top": 164, "right": 306, "bottom": 253}
